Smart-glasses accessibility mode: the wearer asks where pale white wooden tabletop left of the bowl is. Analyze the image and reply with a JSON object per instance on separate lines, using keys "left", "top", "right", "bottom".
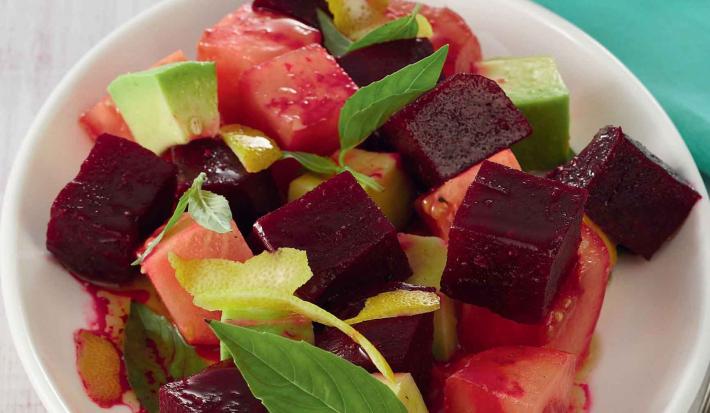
{"left": 0, "top": 0, "right": 158, "bottom": 413}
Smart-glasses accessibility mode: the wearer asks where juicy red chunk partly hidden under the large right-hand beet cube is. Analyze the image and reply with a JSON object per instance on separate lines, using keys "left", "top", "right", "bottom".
{"left": 458, "top": 224, "right": 613, "bottom": 363}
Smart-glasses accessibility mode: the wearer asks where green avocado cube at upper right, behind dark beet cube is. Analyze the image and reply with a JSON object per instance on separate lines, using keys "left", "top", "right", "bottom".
{"left": 479, "top": 56, "right": 569, "bottom": 171}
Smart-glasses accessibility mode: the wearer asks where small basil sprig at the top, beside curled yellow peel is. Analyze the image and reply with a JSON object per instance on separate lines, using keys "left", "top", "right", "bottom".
{"left": 316, "top": 4, "right": 421, "bottom": 56}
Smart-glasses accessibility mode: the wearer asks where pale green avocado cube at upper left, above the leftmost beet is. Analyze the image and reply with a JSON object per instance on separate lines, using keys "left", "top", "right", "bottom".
{"left": 108, "top": 62, "right": 219, "bottom": 154}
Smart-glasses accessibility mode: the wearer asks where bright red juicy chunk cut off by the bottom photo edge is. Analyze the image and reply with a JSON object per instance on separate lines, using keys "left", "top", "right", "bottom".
{"left": 444, "top": 346, "right": 575, "bottom": 413}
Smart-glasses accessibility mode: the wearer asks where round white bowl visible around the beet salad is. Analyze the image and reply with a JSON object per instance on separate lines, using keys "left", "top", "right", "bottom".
{"left": 0, "top": 0, "right": 710, "bottom": 413}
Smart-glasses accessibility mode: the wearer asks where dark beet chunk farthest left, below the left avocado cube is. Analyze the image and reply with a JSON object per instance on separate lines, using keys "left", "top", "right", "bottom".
{"left": 47, "top": 135, "right": 175, "bottom": 284}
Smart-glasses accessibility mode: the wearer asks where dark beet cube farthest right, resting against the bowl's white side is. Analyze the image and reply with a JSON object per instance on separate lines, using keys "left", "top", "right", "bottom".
{"left": 549, "top": 126, "right": 700, "bottom": 259}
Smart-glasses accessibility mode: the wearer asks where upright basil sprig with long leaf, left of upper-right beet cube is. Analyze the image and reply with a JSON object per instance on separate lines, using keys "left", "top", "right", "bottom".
{"left": 283, "top": 45, "right": 449, "bottom": 191}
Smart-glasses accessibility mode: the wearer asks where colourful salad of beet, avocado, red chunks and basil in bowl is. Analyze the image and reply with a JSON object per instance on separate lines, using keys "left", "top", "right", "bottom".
{"left": 46, "top": 0, "right": 700, "bottom": 413}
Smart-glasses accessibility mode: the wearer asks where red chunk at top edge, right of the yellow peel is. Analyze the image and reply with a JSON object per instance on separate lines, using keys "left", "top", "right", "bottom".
{"left": 387, "top": 0, "right": 482, "bottom": 76}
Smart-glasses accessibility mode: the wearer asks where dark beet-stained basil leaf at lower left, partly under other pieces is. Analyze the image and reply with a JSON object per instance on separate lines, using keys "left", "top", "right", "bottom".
{"left": 123, "top": 301, "right": 207, "bottom": 413}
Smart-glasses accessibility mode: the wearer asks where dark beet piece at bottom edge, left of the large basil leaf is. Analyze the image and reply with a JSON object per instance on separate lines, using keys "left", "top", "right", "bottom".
{"left": 160, "top": 360, "right": 267, "bottom": 413}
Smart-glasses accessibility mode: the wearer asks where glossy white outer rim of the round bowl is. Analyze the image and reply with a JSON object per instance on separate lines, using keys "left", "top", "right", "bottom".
{"left": 0, "top": 0, "right": 710, "bottom": 412}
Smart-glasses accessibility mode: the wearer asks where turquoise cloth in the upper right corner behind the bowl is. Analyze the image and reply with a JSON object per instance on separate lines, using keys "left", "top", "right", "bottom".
{"left": 537, "top": 0, "right": 710, "bottom": 183}
